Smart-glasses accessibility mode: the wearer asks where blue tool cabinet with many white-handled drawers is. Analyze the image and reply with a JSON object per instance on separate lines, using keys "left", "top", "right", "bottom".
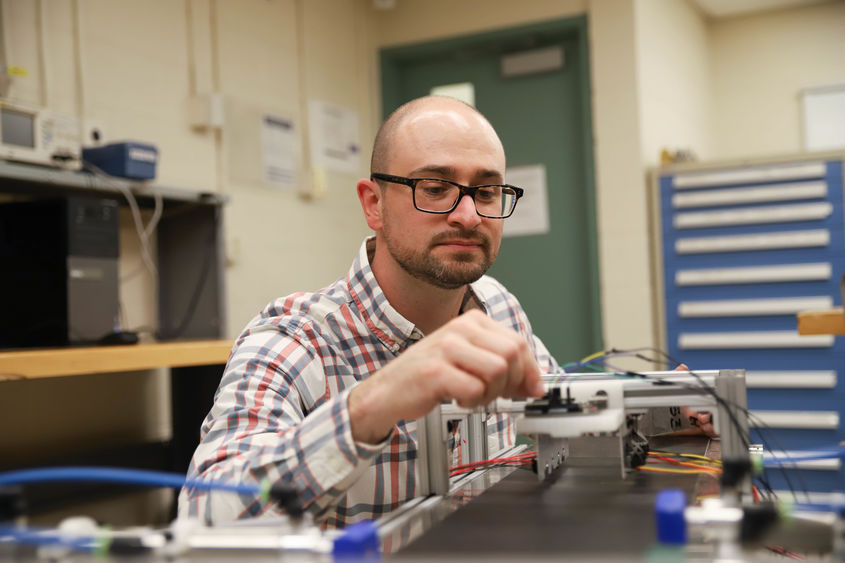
{"left": 656, "top": 154, "right": 845, "bottom": 500}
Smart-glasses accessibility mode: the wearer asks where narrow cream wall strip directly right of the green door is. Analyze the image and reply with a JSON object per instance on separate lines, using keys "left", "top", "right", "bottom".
{"left": 589, "top": 0, "right": 652, "bottom": 354}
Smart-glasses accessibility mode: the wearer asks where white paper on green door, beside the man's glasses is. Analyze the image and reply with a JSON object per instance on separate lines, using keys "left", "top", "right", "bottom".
{"left": 502, "top": 164, "right": 549, "bottom": 237}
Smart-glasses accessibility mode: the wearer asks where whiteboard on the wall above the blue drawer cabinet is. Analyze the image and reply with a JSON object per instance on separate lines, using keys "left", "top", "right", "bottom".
{"left": 801, "top": 84, "right": 845, "bottom": 151}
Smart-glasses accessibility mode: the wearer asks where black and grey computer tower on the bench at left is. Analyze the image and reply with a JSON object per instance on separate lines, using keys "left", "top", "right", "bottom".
{"left": 0, "top": 197, "right": 120, "bottom": 348}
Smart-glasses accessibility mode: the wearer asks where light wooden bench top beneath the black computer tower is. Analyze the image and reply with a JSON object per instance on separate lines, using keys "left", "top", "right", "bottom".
{"left": 0, "top": 340, "right": 232, "bottom": 381}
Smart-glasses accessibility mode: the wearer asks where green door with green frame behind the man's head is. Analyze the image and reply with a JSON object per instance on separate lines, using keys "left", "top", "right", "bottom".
{"left": 381, "top": 18, "right": 602, "bottom": 364}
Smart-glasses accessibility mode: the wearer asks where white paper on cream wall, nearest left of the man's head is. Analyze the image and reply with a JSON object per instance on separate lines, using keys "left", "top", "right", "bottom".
{"left": 308, "top": 100, "right": 361, "bottom": 174}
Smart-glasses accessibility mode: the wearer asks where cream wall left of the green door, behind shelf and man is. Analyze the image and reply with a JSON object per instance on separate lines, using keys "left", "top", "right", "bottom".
{"left": 0, "top": 0, "right": 379, "bottom": 522}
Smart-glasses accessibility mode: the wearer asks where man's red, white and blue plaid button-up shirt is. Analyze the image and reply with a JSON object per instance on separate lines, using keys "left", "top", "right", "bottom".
{"left": 179, "top": 238, "right": 557, "bottom": 527}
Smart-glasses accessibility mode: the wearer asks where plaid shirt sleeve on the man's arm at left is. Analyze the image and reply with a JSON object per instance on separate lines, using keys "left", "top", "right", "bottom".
{"left": 179, "top": 328, "right": 392, "bottom": 522}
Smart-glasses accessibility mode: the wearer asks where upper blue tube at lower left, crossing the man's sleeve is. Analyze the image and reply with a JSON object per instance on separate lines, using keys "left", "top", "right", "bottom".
{"left": 0, "top": 467, "right": 264, "bottom": 495}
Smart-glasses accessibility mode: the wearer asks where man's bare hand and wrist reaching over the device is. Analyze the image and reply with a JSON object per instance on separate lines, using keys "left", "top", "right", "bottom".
{"left": 349, "top": 311, "right": 544, "bottom": 443}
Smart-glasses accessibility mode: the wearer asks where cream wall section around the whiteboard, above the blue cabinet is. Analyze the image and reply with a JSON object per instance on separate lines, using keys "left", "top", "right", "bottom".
{"left": 710, "top": 0, "right": 845, "bottom": 160}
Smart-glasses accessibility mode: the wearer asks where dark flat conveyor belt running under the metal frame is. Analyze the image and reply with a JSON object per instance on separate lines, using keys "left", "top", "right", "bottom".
{"left": 391, "top": 438, "right": 718, "bottom": 560}
